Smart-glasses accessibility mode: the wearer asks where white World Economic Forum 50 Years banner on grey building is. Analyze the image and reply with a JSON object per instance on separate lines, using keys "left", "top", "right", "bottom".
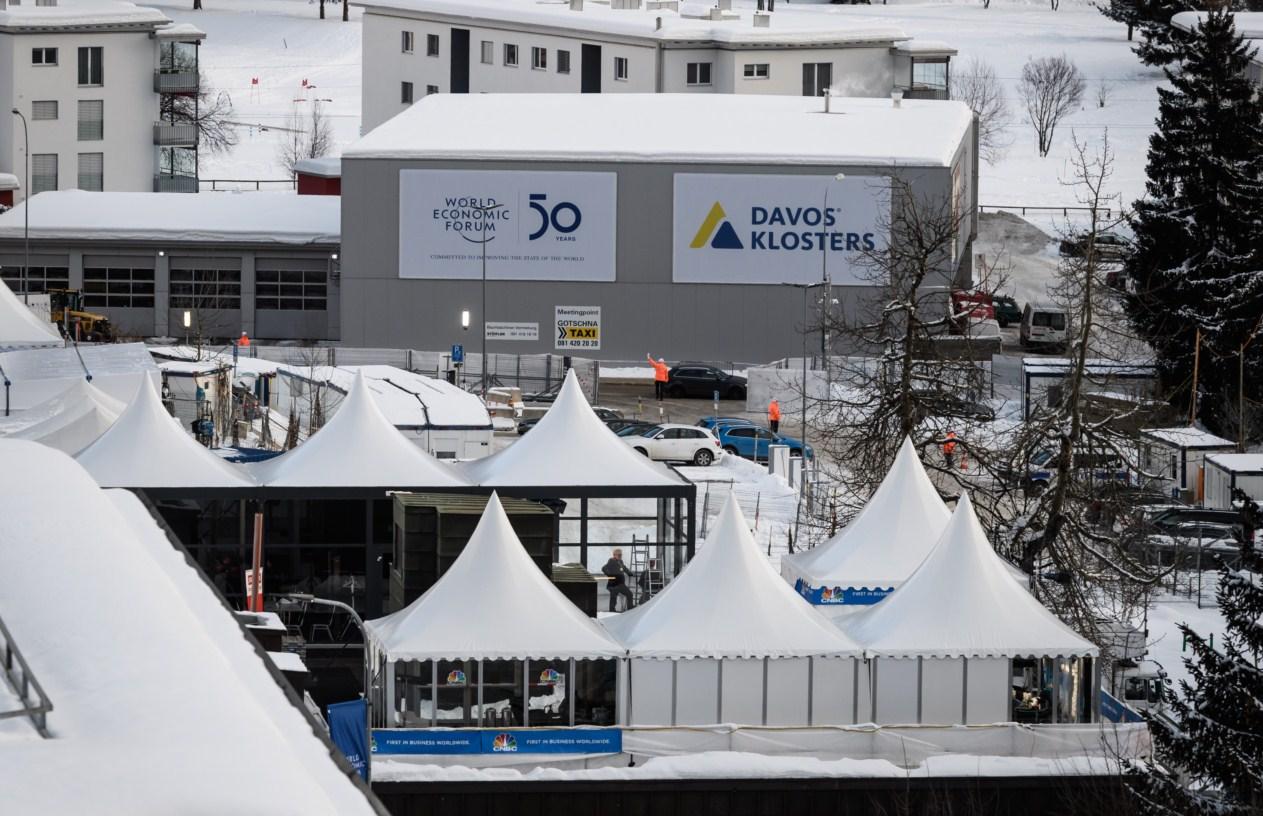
{"left": 399, "top": 171, "right": 618, "bottom": 282}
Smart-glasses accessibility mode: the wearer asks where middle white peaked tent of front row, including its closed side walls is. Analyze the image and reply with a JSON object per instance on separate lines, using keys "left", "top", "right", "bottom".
{"left": 602, "top": 499, "right": 859, "bottom": 725}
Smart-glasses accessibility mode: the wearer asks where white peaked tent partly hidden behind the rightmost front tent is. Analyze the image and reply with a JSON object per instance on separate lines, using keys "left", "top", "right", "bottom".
{"left": 781, "top": 438, "right": 951, "bottom": 604}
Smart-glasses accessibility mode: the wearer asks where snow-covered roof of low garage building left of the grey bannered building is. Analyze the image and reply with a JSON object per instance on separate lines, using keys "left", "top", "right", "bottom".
{"left": 0, "top": 189, "right": 342, "bottom": 245}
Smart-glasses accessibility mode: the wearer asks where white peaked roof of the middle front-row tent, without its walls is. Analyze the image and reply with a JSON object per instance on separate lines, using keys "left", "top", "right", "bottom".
{"left": 598, "top": 495, "right": 859, "bottom": 658}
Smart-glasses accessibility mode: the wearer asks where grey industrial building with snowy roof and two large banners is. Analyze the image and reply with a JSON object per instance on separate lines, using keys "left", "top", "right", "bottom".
{"left": 341, "top": 93, "right": 978, "bottom": 361}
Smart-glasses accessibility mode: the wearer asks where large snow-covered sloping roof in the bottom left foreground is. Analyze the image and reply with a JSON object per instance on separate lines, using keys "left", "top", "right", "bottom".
{"left": 0, "top": 440, "right": 374, "bottom": 815}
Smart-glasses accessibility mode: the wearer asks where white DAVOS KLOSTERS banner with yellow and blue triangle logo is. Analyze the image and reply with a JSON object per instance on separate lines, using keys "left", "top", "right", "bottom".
{"left": 672, "top": 173, "right": 890, "bottom": 285}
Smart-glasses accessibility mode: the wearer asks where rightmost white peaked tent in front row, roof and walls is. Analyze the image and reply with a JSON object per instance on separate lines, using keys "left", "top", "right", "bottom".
{"left": 842, "top": 495, "right": 1099, "bottom": 724}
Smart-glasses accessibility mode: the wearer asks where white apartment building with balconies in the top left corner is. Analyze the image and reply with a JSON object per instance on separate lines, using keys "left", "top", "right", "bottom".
{"left": 0, "top": 0, "right": 206, "bottom": 203}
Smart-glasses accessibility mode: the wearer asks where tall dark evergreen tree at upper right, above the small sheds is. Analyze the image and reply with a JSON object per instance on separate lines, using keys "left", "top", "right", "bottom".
{"left": 1125, "top": 11, "right": 1263, "bottom": 432}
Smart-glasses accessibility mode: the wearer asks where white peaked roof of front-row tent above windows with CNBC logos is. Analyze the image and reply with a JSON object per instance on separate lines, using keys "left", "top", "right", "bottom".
{"left": 365, "top": 493, "right": 624, "bottom": 662}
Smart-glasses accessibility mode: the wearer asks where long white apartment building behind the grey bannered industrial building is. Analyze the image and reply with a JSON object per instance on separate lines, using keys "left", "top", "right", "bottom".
{"left": 359, "top": 0, "right": 956, "bottom": 133}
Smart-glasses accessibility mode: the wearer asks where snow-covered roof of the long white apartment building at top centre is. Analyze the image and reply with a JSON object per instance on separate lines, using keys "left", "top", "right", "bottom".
{"left": 356, "top": 0, "right": 908, "bottom": 47}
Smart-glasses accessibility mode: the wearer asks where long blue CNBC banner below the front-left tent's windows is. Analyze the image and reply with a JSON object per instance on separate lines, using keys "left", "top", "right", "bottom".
{"left": 373, "top": 728, "right": 623, "bottom": 755}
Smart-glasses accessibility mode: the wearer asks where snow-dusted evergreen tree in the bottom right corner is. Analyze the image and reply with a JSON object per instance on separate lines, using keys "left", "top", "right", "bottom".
{"left": 1135, "top": 489, "right": 1263, "bottom": 816}
